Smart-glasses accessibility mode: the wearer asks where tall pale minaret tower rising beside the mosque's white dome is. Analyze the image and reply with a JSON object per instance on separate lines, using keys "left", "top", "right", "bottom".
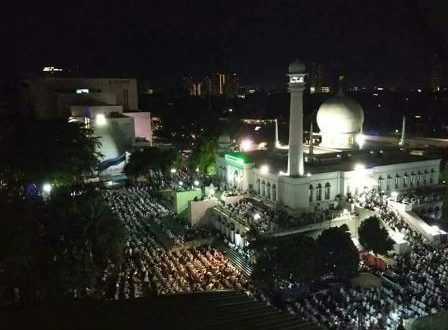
{"left": 288, "top": 60, "right": 306, "bottom": 176}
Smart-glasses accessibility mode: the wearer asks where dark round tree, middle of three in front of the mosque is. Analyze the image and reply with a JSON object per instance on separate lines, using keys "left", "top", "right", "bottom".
{"left": 316, "top": 226, "right": 359, "bottom": 279}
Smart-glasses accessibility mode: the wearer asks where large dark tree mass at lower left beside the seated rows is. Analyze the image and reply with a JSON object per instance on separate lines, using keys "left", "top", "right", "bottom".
{"left": 0, "top": 187, "right": 127, "bottom": 301}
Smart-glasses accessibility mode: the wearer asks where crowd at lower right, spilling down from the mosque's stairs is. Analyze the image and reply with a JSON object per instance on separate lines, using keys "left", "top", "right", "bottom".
{"left": 247, "top": 191, "right": 448, "bottom": 329}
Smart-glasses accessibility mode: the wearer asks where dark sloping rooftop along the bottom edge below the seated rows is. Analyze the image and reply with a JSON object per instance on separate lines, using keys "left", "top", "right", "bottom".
{"left": 0, "top": 291, "right": 320, "bottom": 330}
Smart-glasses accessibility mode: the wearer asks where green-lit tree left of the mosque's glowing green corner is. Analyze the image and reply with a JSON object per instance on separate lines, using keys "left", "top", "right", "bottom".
{"left": 190, "top": 137, "right": 218, "bottom": 174}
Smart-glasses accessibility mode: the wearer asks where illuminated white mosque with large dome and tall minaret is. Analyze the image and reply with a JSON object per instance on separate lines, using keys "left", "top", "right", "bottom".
{"left": 216, "top": 61, "right": 441, "bottom": 212}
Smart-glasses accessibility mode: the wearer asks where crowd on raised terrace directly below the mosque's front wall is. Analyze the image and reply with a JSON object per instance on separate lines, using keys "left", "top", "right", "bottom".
{"left": 218, "top": 198, "right": 336, "bottom": 233}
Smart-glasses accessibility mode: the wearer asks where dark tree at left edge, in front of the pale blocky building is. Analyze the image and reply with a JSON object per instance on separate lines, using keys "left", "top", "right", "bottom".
{"left": 0, "top": 116, "right": 99, "bottom": 188}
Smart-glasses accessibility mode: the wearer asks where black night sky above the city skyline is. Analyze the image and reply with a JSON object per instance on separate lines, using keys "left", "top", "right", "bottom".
{"left": 0, "top": 0, "right": 448, "bottom": 86}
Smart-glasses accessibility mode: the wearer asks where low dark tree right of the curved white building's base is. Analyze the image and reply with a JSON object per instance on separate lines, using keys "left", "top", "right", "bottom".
{"left": 124, "top": 147, "right": 180, "bottom": 177}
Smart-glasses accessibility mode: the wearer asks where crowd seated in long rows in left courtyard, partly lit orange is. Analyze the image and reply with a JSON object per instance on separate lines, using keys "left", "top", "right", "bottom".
{"left": 99, "top": 186, "right": 250, "bottom": 299}
